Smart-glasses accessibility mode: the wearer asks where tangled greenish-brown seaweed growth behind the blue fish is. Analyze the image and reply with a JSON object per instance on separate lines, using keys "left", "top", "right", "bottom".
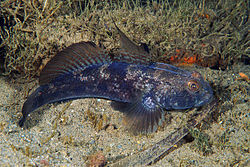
{"left": 0, "top": 0, "right": 249, "bottom": 79}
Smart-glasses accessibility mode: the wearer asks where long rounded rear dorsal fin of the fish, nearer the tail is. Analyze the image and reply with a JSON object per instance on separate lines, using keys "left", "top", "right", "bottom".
{"left": 39, "top": 42, "right": 110, "bottom": 85}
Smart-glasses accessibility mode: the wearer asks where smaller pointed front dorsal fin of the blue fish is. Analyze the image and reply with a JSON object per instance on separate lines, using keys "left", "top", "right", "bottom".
{"left": 113, "top": 21, "right": 151, "bottom": 64}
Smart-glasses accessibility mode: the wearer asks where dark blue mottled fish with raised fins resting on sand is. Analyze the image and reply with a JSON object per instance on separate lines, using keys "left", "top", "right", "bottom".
{"left": 18, "top": 24, "right": 213, "bottom": 133}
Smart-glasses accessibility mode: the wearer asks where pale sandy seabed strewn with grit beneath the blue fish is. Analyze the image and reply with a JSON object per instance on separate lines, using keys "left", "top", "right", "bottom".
{"left": 0, "top": 64, "right": 250, "bottom": 166}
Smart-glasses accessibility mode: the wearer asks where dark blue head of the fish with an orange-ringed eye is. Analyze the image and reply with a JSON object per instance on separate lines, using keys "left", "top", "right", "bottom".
{"left": 160, "top": 71, "right": 213, "bottom": 109}
